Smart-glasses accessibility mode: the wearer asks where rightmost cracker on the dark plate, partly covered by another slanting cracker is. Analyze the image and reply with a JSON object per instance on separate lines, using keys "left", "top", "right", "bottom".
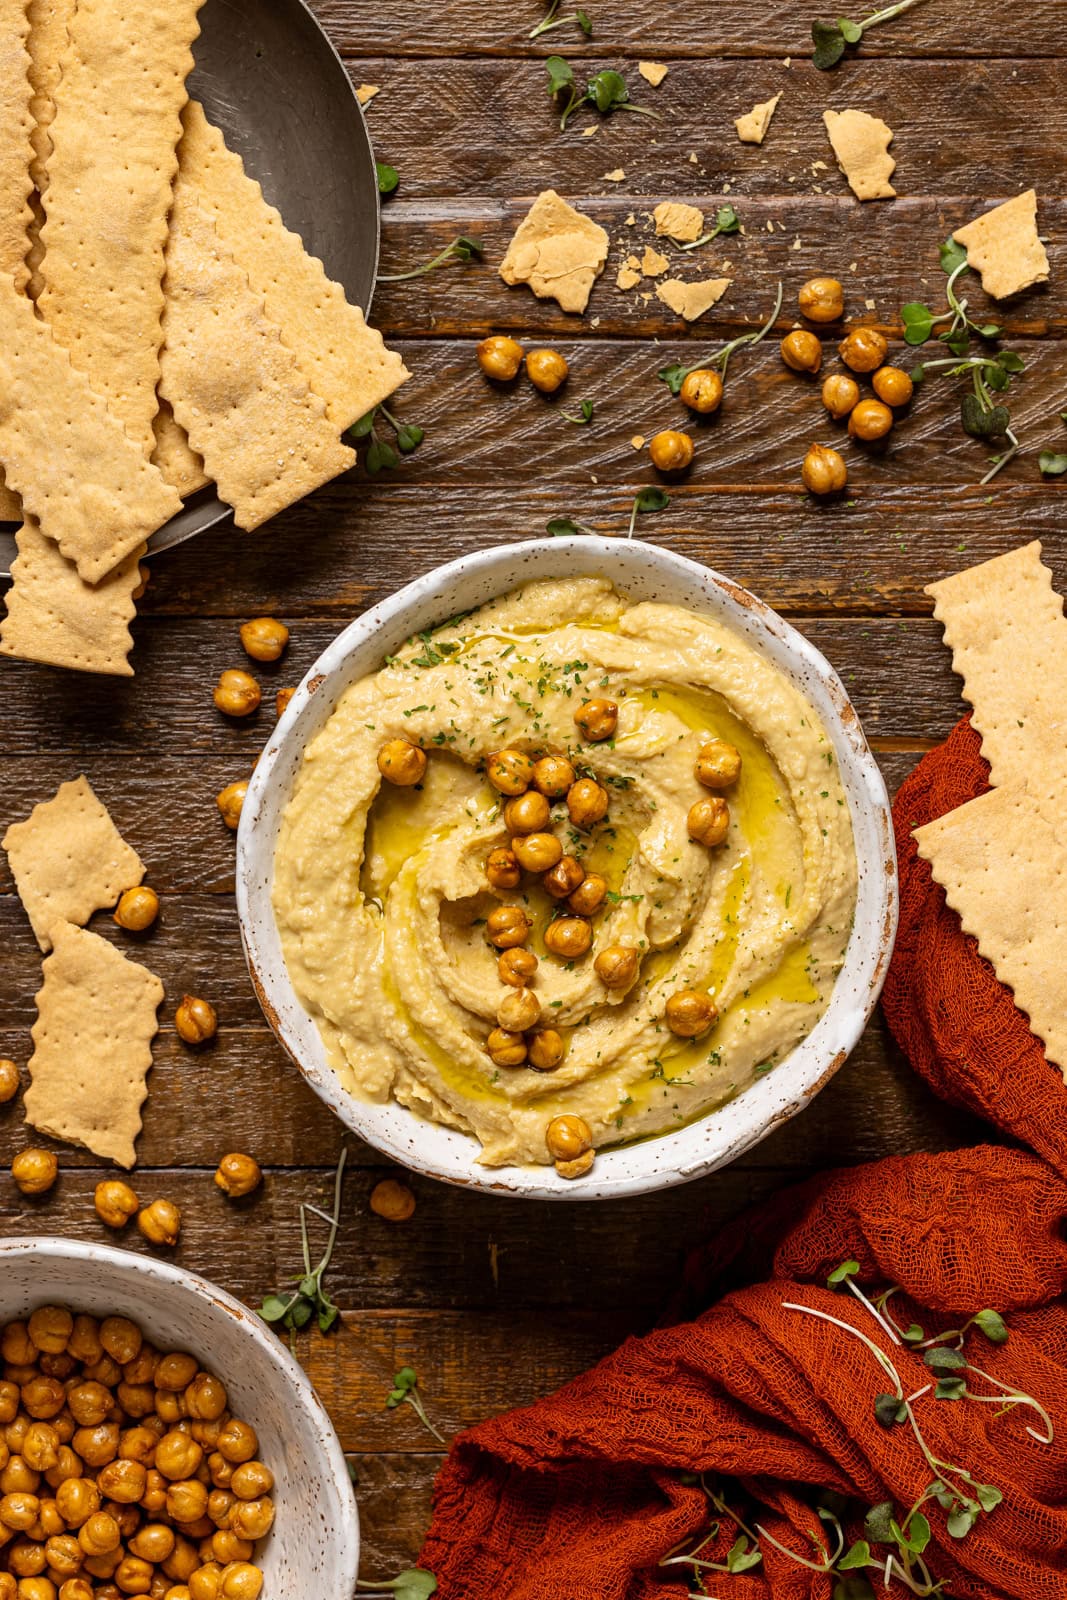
{"left": 178, "top": 101, "right": 411, "bottom": 434}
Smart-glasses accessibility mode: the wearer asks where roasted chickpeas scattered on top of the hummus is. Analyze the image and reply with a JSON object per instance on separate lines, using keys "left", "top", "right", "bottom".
{"left": 378, "top": 698, "right": 741, "bottom": 1178}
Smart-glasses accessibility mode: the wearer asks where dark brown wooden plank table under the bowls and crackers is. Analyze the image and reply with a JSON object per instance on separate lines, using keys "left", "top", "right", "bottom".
{"left": 0, "top": 0, "right": 1067, "bottom": 1576}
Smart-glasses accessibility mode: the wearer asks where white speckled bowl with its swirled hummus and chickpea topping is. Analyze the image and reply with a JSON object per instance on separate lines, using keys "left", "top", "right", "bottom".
{"left": 237, "top": 536, "right": 896, "bottom": 1198}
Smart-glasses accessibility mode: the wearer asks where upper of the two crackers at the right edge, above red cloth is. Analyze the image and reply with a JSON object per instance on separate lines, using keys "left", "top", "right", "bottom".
{"left": 926, "top": 539, "right": 1067, "bottom": 784}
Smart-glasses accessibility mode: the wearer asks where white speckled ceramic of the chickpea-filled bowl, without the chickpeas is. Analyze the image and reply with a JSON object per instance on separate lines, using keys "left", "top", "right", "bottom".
{"left": 0, "top": 1238, "right": 360, "bottom": 1600}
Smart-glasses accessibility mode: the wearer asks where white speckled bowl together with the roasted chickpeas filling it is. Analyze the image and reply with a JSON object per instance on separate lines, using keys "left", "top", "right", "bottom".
{"left": 0, "top": 1238, "right": 360, "bottom": 1600}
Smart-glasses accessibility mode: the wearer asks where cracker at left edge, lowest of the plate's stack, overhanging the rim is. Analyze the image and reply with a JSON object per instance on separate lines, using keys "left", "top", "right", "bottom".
{"left": 0, "top": 522, "right": 144, "bottom": 678}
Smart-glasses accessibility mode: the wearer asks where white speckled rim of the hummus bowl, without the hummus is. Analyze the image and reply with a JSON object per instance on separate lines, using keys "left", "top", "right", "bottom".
{"left": 237, "top": 536, "right": 897, "bottom": 1200}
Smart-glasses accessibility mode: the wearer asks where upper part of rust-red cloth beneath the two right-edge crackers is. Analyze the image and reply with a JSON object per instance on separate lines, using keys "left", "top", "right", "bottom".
{"left": 881, "top": 717, "right": 1067, "bottom": 1178}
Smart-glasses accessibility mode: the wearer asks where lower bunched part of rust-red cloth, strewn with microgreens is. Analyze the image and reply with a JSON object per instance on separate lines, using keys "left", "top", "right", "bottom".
{"left": 421, "top": 1147, "right": 1067, "bottom": 1600}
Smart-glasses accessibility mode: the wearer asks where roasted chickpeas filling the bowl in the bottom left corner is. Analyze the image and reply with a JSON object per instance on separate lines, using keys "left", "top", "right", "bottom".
{"left": 0, "top": 1306, "right": 274, "bottom": 1600}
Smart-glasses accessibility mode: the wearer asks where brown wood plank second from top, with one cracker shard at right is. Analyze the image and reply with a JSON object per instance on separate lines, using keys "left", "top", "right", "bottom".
{"left": 349, "top": 58, "right": 1067, "bottom": 198}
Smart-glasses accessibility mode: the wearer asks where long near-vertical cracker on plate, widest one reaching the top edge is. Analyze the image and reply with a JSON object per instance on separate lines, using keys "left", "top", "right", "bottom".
{"left": 38, "top": 0, "right": 200, "bottom": 456}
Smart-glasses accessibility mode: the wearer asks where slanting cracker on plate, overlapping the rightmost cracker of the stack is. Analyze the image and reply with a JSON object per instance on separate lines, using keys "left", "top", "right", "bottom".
{"left": 160, "top": 176, "right": 355, "bottom": 530}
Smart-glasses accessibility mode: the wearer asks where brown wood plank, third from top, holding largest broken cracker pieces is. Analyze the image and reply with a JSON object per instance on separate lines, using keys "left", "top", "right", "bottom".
{"left": 373, "top": 197, "right": 1067, "bottom": 340}
